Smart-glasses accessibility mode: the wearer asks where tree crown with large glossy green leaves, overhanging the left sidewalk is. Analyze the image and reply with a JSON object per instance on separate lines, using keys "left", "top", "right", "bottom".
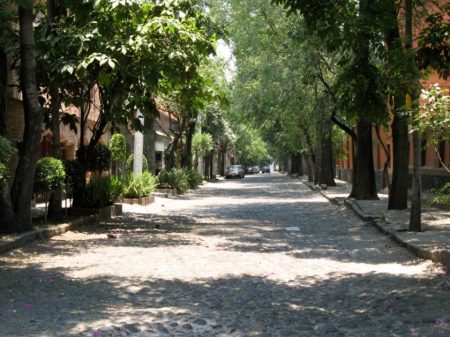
{"left": 33, "top": 0, "right": 215, "bottom": 204}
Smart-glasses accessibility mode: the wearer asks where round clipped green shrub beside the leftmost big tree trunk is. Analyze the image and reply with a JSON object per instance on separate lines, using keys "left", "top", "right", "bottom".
{"left": 34, "top": 157, "right": 66, "bottom": 192}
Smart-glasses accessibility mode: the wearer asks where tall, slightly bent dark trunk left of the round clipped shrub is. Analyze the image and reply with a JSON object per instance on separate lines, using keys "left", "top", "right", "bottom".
{"left": 5, "top": 0, "right": 44, "bottom": 232}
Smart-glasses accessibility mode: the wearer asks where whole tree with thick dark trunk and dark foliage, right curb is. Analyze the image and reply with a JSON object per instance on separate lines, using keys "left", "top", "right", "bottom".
{"left": 273, "top": 0, "right": 394, "bottom": 199}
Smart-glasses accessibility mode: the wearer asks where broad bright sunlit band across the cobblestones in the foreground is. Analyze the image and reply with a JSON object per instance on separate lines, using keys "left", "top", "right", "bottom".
{"left": 24, "top": 241, "right": 436, "bottom": 282}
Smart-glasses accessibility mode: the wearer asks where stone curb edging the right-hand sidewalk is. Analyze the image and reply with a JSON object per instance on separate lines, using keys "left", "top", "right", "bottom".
{"left": 303, "top": 181, "right": 450, "bottom": 270}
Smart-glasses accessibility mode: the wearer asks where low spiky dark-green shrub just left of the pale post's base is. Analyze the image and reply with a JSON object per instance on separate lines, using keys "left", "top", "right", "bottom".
{"left": 84, "top": 176, "right": 122, "bottom": 208}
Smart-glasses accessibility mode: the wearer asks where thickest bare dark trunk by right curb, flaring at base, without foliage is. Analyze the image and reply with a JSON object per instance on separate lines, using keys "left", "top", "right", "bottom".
{"left": 350, "top": 119, "right": 378, "bottom": 200}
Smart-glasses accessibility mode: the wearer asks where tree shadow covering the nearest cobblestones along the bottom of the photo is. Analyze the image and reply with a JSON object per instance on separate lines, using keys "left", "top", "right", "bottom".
{"left": 0, "top": 264, "right": 450, "bottom": 337}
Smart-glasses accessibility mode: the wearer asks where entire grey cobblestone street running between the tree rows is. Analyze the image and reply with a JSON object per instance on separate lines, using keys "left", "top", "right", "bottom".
{"left": 0, "top": 174, "right": 450, "bottom": 337}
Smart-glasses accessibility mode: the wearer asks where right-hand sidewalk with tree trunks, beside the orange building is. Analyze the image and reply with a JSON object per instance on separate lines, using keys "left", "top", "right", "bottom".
{"left": 302, "top": 180, "right": 450, "bottom": 270}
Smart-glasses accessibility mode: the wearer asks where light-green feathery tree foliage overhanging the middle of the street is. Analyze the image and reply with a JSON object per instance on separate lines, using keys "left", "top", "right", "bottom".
{"left": 218, "top": 0, "right": 342, "bottom": 185}
